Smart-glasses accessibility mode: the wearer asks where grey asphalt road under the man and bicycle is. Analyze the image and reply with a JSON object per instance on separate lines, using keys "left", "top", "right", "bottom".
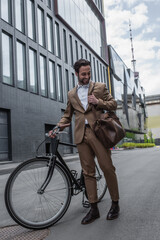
{"left": 0, "top": 147, "right": 160, "bottom": 240}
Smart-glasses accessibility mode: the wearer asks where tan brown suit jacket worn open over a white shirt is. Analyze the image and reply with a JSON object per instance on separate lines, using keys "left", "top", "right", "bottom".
{"left": 58, "top": 81, "right": 117, "bottom": 144}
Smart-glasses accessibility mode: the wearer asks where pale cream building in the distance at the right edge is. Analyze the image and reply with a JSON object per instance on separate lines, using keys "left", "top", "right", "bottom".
{"left": 146, "top": 95, "right": 160, "bottom": 145}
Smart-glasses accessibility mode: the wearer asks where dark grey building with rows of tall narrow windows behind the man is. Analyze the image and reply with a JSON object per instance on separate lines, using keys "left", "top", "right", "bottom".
{"left": 0, "top": 0, "right": 108, "bottom": 161}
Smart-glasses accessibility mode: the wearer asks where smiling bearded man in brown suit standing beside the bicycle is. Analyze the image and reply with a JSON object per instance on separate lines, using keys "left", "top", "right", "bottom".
{"left": 52, "top": 59, "right": 119, "bottom": 224}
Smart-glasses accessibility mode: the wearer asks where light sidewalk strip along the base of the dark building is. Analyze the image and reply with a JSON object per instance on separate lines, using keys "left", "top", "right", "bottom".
{"left": 0, "top": 153, "right": 79, "bottom": 175}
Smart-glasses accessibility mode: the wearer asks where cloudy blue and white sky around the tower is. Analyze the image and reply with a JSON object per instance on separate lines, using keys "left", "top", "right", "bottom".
{"left": 104, "top": 0, "right": 160, "bottom": 96}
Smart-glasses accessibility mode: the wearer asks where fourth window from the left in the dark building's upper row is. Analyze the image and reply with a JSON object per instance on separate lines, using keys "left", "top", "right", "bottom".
{"left": 38, "top": 8, "right": 45, "bottom": 47}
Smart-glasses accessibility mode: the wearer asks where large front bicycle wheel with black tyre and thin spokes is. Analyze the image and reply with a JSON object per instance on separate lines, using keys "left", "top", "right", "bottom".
{"left": 5, "top": 159, "right": 71, "bottom": 229}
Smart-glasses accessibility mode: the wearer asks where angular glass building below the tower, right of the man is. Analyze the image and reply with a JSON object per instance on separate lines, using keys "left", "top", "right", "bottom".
{"left": 109, "top": 46, "right": 147, "bottom": 140}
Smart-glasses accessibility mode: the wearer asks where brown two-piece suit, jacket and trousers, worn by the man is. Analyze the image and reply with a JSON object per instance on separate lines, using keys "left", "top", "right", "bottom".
{"left": 59, "top": 81, "right": 119, "bottom": 203}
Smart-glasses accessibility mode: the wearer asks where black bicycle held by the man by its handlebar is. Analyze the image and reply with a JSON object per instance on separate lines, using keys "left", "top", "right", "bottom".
{"left": 5, "top": 124, "right": 107, "bottom": 229}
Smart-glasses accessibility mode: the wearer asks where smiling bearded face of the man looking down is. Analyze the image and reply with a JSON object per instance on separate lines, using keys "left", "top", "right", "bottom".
{"left": 76, "top": 65, "right": 91, "bottom": 85}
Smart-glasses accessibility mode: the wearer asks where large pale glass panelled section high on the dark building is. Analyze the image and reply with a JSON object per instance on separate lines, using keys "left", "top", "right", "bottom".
{"left": 58, "top": 0, "right": 102, "bottom": 55}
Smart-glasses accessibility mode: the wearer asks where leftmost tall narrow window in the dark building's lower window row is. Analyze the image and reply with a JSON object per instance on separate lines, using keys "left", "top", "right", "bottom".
{"left": 2, "top": 33, "right": 13, "bottom": 85}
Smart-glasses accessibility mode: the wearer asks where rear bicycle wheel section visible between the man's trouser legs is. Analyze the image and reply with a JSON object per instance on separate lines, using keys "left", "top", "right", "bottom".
{"left": 95, "top": 162, "right": 107, "bottom": 202}
